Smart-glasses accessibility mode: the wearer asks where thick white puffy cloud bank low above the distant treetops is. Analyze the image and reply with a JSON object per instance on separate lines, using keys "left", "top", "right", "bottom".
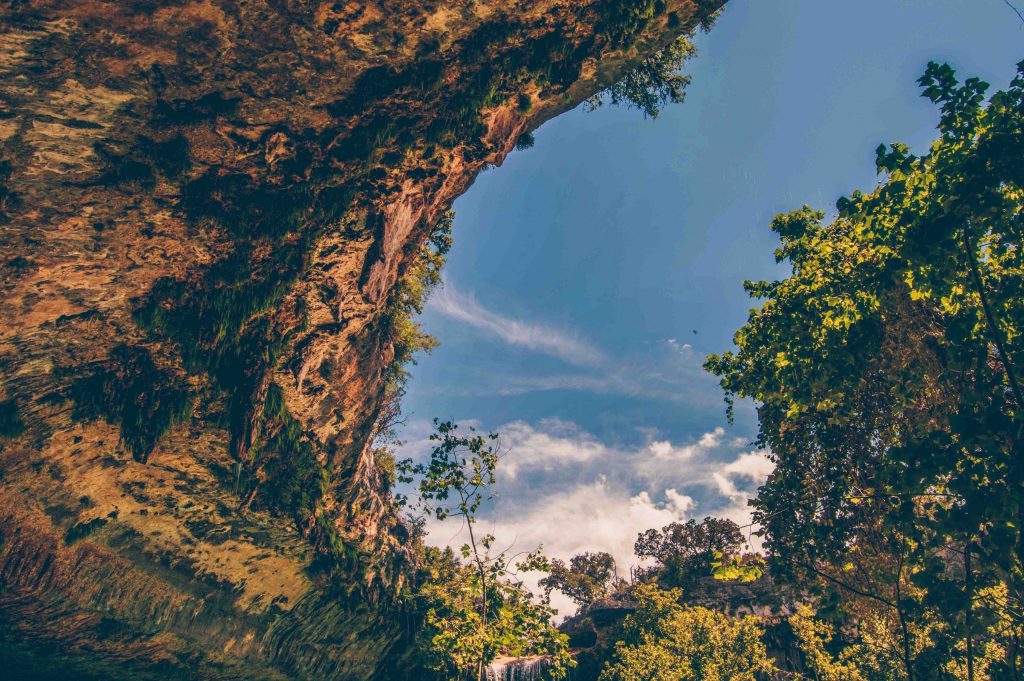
{"left": 407, "top": 419, "right": 772, "bottom": 605}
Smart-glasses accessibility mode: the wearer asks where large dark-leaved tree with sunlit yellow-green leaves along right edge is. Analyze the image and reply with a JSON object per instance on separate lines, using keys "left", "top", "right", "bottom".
{"left": 706, "top": 62, "right": 1024, "bottom": 679}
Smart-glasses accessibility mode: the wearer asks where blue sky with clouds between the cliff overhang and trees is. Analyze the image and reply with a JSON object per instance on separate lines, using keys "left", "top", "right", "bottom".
{"left": 395, "top": 0, "right": 1024, "bottom": 610}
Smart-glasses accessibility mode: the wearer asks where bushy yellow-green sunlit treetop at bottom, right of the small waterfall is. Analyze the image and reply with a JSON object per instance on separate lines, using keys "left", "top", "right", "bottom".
{"left": 600, "top": 584, "right": 773, "bottom": 681}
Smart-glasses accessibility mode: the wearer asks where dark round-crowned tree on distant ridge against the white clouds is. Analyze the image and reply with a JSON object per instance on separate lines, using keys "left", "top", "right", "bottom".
{"left": 634, "top": 517, "right": 745, "bottom": 586}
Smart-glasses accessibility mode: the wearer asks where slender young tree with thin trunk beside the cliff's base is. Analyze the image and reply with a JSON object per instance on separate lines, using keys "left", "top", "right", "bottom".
{"left": 396, "top": 419, "right": 572, "bottom": 681}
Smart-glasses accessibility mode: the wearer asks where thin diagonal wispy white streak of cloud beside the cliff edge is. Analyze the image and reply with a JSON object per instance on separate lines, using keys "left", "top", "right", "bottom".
{"left": 430, "top": 282, "right": 605, "bottom": 367}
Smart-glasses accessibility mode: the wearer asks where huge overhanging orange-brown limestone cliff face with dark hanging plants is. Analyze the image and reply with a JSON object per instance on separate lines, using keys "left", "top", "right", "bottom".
{"left": 0, "top": 0, "right": 722, "bottom": 679}
